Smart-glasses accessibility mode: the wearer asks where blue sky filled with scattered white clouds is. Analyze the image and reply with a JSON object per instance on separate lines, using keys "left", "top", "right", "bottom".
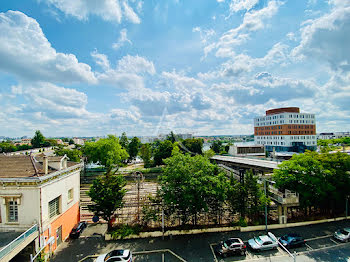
{"left": 0, "top": 0, "right": 350, "bottom": 137}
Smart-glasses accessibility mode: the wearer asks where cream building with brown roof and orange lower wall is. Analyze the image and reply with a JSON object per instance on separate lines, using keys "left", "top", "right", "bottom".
{"left": 0, "top": 154, "right": 82, "bottom": 261}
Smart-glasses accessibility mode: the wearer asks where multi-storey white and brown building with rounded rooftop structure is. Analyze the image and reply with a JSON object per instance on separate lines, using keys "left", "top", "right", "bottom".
{"left": 254, "top": 107, "right": 317, "bottom": 152}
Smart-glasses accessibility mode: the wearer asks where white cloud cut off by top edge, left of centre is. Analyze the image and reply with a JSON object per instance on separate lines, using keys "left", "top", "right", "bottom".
{"left": 45, "top": 0, "right": 140, "bottom": 24}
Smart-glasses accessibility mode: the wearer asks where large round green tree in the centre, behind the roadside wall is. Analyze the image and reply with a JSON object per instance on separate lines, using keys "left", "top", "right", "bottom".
{"left": 159, "top": 153, "right": 227, "bottom": 225}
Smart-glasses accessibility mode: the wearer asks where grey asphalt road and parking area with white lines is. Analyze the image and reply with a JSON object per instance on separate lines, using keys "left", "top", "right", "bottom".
{"left": 50, "top": 221, "right": 350, "bottom": 262}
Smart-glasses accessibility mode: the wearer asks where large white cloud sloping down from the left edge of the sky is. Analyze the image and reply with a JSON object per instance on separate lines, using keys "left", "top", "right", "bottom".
{"left": 0, "top": 11, "right": 96, "bottom": 83}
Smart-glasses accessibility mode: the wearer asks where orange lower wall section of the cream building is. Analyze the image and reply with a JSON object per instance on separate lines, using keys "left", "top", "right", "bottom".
{"left": 43, "top": 202, "right": 80, "bottom": 251}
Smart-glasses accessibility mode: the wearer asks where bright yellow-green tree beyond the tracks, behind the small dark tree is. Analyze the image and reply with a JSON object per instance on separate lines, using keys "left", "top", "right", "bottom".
{"left": 83, "top": 135, "right": 129, "bottom": 169}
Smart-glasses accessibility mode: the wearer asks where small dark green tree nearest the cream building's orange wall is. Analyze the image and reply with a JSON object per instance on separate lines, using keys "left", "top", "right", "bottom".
{"left": 88, "top": 171, "right": 126, "bottom": 230}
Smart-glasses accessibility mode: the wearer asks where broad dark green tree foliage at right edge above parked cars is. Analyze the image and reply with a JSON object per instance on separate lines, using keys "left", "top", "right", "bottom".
{"left": 274, "top": 151, "right": 350, "bottom": 210}
